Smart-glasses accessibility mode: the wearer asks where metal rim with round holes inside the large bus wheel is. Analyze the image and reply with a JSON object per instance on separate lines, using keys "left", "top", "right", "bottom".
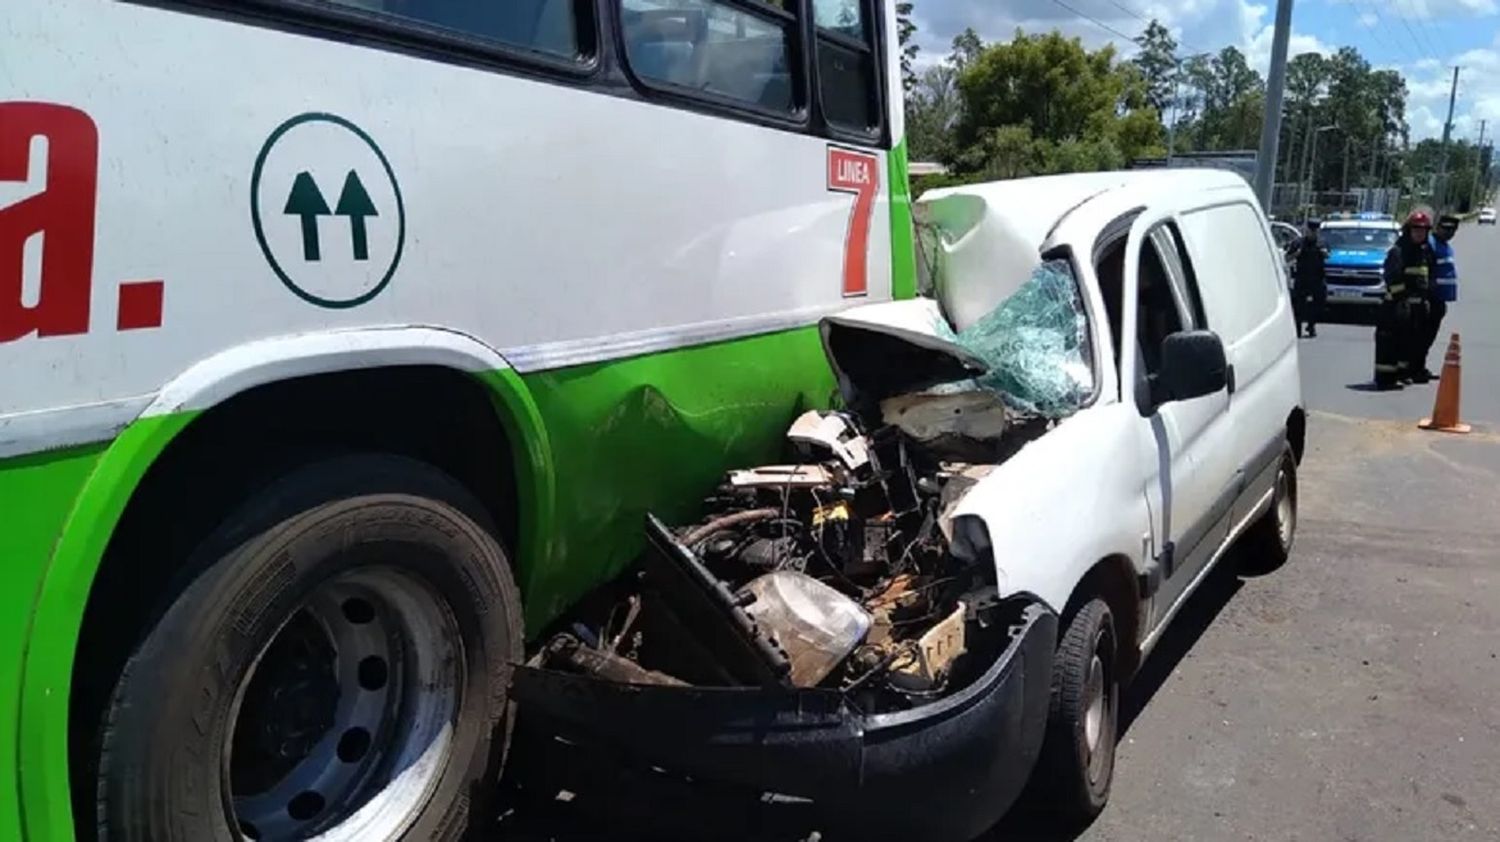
{"left": 222, "top": 567, "right": 464, "bottom": 842}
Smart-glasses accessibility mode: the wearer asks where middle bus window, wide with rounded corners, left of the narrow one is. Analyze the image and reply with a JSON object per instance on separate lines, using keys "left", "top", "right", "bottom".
{"left": 621, "top": 0, "right": 797, "bottom": 113}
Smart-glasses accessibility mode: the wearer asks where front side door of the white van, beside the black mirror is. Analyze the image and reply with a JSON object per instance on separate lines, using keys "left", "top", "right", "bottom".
{"left": 1121, "top": 215, "right": 1239, "bottom": 627}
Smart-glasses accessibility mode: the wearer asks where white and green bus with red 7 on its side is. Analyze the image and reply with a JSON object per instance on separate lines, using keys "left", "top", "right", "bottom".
{"left": 0, "top": 0, "right": 915, "bottom": 842}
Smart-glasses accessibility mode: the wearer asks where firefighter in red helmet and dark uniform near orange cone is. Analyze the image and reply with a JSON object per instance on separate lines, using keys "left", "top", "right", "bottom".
{"left": 1376, "top": 210, "right": 1436, "bottom": 389}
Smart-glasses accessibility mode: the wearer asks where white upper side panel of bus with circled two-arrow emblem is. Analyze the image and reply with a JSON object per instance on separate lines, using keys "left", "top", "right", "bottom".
{"left": 0, "top": 0, "right": 891, "bottom": 423}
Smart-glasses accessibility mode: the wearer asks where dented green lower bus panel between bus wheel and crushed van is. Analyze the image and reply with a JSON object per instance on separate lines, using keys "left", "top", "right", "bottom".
{"left": 522, "top": 321, "right": 836, "bottom": 633}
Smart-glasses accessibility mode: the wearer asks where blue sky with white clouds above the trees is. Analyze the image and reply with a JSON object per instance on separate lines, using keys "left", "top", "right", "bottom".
{"left": 912, "top": 0, "right": 1500, "bottom": 140}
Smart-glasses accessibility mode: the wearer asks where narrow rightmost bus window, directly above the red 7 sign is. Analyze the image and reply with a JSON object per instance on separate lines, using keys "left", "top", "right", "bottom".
{"left": 813, "top": 0, "right": 881, "bottom": 132}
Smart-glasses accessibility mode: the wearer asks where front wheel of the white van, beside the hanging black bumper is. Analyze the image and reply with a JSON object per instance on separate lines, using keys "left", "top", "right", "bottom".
{"left": 1032, "top": 599, "right": 1119, "bottom": 824}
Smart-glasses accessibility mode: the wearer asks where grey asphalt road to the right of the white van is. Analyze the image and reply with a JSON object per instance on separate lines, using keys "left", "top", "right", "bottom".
{"left": 1056, "top": 227, "right": 1500, "bottom": 842}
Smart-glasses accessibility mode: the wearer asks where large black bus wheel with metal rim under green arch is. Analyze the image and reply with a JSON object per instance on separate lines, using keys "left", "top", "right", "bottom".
{"left": 99, "top": 456, "right": 522, "bottom": 842}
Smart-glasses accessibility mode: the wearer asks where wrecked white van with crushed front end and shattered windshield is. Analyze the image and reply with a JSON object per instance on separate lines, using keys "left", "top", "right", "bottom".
{"left": 513, "top": 170, "right": 1307, "bottom": 842}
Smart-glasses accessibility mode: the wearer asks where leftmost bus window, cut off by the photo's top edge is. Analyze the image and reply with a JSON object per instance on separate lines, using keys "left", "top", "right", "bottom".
{"left": 326, "top": 0, "right": 581, "bottom": 59}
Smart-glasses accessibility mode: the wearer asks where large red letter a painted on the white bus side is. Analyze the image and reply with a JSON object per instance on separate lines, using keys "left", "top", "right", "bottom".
{"left": 0, "top": 102, "right": 99, "bottom": 342}
